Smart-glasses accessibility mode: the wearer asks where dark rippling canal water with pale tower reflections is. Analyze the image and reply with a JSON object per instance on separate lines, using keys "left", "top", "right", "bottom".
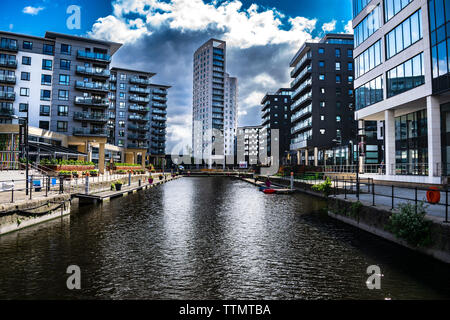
{"left": 0, "top": 178, "right": 450, "bottom": 299}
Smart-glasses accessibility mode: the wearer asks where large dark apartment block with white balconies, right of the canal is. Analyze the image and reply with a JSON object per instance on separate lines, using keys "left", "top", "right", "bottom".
{"left": 290, "top": 34, "right": 356, "bottom": 166}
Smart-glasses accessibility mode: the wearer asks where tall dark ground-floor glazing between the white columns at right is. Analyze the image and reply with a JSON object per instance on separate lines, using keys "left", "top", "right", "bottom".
{"left": 395, "top": 109, "right": 428, "bottom": 175}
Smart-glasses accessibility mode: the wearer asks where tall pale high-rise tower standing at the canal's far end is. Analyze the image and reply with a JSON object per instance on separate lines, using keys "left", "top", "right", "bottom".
{"left": 192, "top": 39, "right": 238, "bottom": 166}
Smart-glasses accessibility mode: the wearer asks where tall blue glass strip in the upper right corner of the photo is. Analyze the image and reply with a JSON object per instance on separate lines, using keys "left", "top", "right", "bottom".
{"left": 428, "top": 0, "right": 450, "bottom": 93}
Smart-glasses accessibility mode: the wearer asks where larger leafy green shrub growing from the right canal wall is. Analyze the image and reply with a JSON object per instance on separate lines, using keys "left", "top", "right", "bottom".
{"left": 386, "top": 202, "right": 432, "bottom": 247}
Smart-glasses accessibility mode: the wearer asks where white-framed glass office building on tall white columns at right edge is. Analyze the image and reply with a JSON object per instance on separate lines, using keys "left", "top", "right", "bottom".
{"left": 353, "top": 0, "right": 450, "bottom": 184}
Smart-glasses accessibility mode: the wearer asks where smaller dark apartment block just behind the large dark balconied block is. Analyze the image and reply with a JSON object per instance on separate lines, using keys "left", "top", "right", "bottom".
{"left": 261, "top": 88, "right": 292, "bottom": 165}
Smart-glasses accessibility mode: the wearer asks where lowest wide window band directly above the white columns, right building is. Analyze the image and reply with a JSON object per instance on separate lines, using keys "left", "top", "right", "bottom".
{"left": 387, "top": 53, "right": 425, "bottom": 98}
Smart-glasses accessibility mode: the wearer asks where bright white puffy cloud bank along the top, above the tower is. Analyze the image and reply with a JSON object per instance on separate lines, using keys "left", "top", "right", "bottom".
{"left": 89, "top": 0, "right": 317, "bottom": 48}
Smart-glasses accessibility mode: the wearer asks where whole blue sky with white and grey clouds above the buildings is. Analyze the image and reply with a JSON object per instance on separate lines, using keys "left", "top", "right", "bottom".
{"left": 0, "top": 0, "right": 351, "bottom": 153}
